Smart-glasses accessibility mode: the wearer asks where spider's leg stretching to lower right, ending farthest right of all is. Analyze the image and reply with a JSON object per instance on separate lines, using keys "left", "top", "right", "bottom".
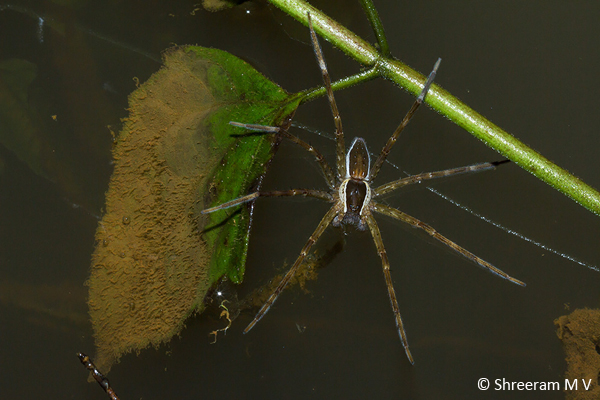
{"left": 371, "top": 201, "right": 526, "bottom": 286}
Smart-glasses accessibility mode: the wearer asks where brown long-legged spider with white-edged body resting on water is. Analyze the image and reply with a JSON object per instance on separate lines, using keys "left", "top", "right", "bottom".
{"left": 202, "top": 14, "right": 525, "bottom": 364}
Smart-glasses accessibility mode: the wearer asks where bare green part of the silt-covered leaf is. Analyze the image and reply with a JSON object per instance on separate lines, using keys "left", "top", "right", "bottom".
{"left": 188, "top": 47, "right": 300, "bottom": 283}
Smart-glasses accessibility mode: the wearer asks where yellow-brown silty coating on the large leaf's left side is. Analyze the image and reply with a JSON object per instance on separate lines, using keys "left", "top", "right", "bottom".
{"left": 87, "top": 50, "right": 216, "bottom": 372}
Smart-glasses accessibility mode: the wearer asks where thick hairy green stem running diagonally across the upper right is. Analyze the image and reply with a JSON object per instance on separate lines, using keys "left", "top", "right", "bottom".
{"left": 269, "top": 0, "right": 600, "bottom": 215}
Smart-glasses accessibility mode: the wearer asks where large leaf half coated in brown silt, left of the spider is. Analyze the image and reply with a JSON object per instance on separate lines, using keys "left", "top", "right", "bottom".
{"left": 88, "top": 43, "right": 299, "bottom": 371}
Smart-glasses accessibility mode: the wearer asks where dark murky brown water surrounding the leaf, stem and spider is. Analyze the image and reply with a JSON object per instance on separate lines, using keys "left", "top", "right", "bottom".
{"left": 0, "top": 1, "right": 600, "bottom": 399}
